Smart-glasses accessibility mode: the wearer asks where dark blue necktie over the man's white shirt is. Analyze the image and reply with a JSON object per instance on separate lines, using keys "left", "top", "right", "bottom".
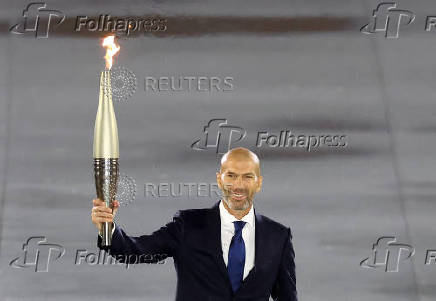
{"left": 227, "top": 221, "right": 245, "bottom": 292}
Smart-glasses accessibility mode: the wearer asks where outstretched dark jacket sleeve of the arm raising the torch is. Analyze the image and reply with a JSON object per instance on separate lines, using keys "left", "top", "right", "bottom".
{"left": 97, "top": 211, "right": 183, "bottom": 263}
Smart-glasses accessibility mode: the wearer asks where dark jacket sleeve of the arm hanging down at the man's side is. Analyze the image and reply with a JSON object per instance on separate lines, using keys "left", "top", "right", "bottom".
{"left": 271, "top": 228, "right": 297, "bottom": 301}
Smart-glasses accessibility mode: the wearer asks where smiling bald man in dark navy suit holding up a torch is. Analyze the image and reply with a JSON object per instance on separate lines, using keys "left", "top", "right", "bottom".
{"left": 91, "top": 148, "right": 297, "bottom": 301}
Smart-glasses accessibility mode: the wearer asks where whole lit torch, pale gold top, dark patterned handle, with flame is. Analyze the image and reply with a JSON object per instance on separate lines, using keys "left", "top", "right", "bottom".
{"left": 94, "top": 36, "right": 120, "bottom": 246}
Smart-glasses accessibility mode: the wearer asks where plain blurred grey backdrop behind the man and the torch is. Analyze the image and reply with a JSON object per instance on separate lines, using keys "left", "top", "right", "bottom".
{"left": 0, "top": 0, "right": 436, "bottom": 301}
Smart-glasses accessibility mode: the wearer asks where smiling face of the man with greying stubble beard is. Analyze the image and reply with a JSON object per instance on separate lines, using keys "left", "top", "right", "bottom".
{"left": 217, "top": 159, "right": 262, "bottom": 210}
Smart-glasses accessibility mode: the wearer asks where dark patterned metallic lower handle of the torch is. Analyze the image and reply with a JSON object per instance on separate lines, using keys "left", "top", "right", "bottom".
{"left": 94, "top": 158, "right": 119, "bottom": 247}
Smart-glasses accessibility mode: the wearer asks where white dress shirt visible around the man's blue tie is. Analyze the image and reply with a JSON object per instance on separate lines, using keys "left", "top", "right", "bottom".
{"left": 219, "top": 201, "right": 255, "bottom": 279}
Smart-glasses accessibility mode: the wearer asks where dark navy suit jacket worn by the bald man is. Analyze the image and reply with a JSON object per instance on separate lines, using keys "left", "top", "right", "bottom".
{"left": 97, "top": 202, "right": 297, "bottom": 301}
